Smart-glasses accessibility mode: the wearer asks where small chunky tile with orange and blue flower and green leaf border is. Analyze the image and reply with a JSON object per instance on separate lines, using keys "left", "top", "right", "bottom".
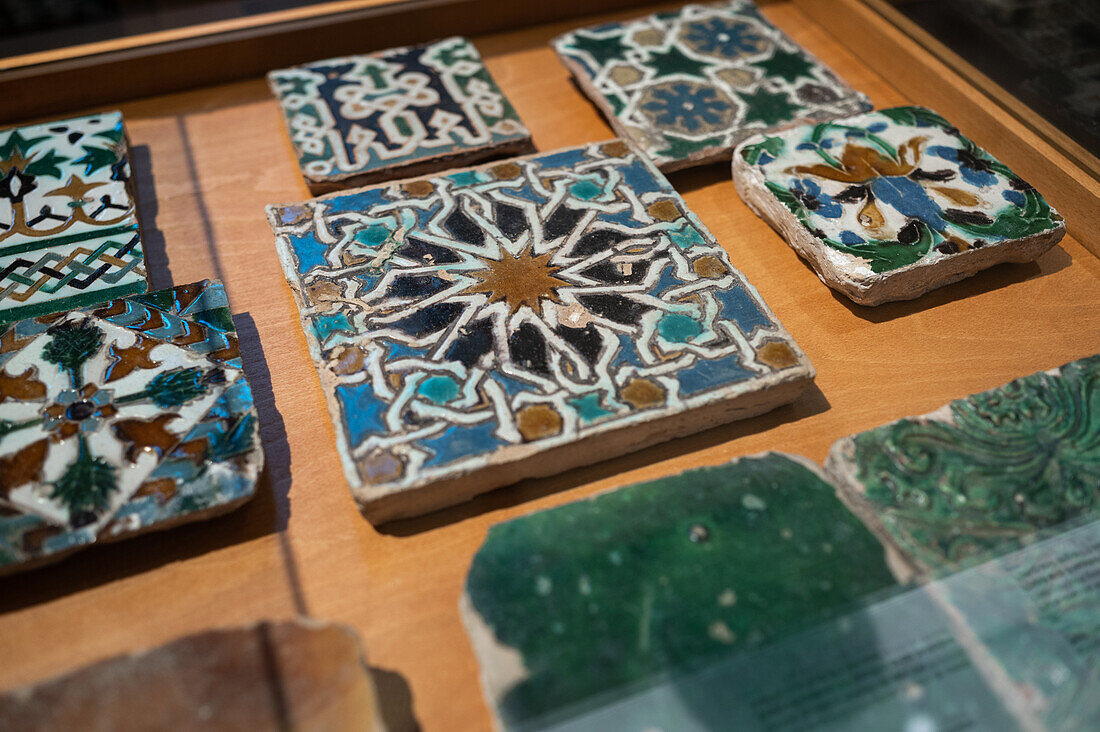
{"left": 734, "top": 107, "right": 1066, "bottom": 305}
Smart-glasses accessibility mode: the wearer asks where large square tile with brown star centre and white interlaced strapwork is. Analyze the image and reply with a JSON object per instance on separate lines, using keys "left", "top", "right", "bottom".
{"left": 267, "top": 141, "right": 813, "bottom": 521}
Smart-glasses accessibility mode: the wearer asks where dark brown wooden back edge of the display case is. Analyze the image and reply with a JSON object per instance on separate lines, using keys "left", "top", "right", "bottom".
{"left": 0, "top": 0, "right": 652, "bottom": 123}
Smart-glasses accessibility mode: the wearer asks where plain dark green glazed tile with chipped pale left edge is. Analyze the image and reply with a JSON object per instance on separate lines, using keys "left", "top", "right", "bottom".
{"left": 462, "top": 454, "right": 897, "bottom": 729}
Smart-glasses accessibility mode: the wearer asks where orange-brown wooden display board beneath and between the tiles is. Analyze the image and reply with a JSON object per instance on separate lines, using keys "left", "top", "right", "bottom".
{"left": 0, "top": 1, "right": 1100, "bottom": 730}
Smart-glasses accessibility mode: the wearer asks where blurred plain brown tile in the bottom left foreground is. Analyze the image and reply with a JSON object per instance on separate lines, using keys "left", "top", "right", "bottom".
{"left": 0, "top": 620, "right": 385, "bottom": 732}
